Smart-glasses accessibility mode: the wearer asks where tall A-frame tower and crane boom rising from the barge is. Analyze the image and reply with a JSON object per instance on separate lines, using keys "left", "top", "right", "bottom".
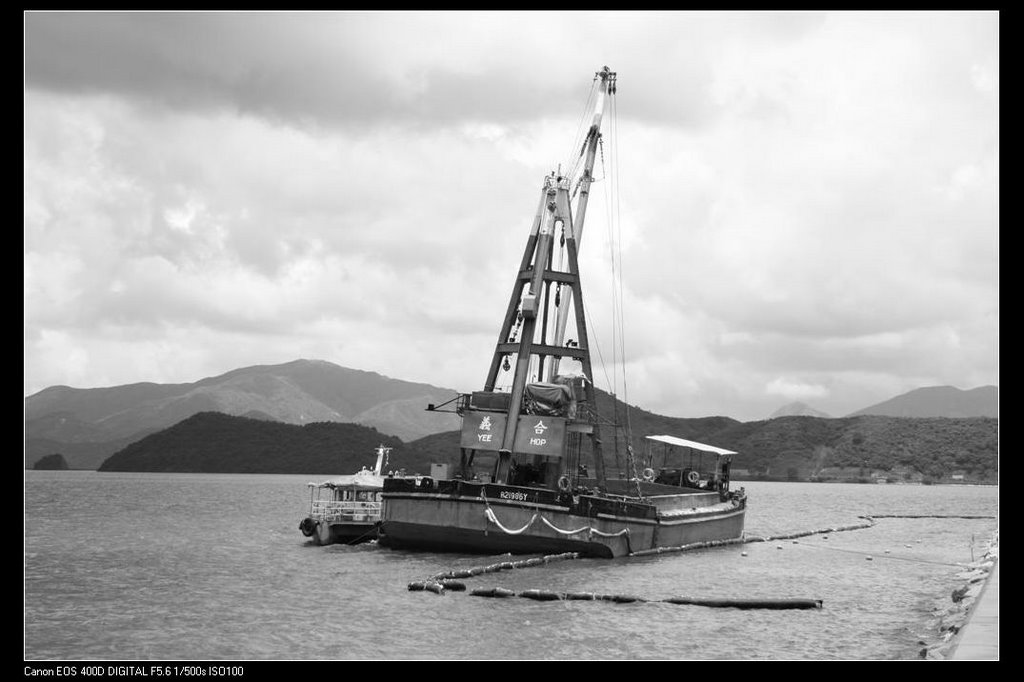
{"left": 484, "top": 67, "right": 615, "bottom": 492}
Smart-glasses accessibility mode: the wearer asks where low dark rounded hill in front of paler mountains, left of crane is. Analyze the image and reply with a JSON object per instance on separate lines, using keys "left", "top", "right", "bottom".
{"left": 99, "top": 412, "right": 429, "bottom": 476}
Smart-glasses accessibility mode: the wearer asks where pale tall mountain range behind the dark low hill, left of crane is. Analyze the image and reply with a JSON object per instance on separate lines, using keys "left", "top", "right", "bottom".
{"left": 25, "top": 360, "right": 459, "bottom": 469}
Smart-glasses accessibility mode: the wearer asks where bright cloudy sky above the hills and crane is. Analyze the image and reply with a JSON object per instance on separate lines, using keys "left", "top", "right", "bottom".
{"left": 24, "top": 11, "right": 999, "bottom": 421}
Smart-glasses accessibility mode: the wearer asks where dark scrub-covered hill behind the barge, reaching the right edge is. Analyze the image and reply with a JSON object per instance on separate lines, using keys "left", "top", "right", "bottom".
{"left": 409, "top": 405, "right": 998, "bottom": 483}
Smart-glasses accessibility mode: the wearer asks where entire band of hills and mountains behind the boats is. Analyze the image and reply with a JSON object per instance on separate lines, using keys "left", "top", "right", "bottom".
{"left": 25, "top": 360, "right": 997, "bottom": 482}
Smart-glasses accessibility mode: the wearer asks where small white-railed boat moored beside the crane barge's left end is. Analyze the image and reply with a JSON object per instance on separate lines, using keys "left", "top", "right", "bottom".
{"left": 299, "top": 445, "right": 391, "bottom": 545}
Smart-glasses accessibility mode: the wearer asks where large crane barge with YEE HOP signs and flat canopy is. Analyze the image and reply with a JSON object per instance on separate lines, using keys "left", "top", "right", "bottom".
{"left": 379, "top": 67, "right": 746, "bottom": 557}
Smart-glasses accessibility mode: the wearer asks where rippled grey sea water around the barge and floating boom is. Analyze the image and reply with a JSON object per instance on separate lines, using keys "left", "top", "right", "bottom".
{"left": 25, "top": 471, "right": 998, "bottom": 662}
